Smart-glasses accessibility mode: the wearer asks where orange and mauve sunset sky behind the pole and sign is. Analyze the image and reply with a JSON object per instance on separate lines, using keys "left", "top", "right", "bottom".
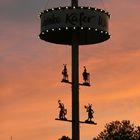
{"left": 0, "top": 0, "right": 140, "bottom": 140}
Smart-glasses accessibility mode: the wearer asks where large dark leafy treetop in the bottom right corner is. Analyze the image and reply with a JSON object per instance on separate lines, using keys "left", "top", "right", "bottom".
{"left": 93, "top": 120, "right": 140, "bottom": 140}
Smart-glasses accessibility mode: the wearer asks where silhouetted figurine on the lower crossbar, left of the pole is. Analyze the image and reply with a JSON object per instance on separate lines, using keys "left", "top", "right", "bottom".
{"left": 58, "top": 100, "right": 67, "bottom": 120}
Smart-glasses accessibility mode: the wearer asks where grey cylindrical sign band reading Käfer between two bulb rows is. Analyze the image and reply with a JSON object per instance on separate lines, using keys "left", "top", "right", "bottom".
{"left": 41, "top": 8, "right": 109, "bottom": 31}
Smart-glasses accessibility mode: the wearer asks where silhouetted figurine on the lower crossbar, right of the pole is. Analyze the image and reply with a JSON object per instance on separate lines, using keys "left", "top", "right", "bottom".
{"left": 85, "top": 104, "right": 94, "bottom": 122}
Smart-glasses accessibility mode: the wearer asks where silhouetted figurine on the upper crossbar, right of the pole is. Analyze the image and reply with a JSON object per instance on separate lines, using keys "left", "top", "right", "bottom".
{"left": 82, "top": 66, "right": 90, "bottom": 86}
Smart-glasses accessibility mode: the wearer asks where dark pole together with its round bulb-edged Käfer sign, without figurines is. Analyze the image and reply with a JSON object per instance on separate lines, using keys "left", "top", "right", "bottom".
{"left": 39, "top": 0, "right": 110, "bottom": 140}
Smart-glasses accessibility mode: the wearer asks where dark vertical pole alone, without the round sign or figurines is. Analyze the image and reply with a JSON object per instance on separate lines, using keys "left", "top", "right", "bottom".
{"left": 72, "top": 0, "right": 80, "bottom": 140}
